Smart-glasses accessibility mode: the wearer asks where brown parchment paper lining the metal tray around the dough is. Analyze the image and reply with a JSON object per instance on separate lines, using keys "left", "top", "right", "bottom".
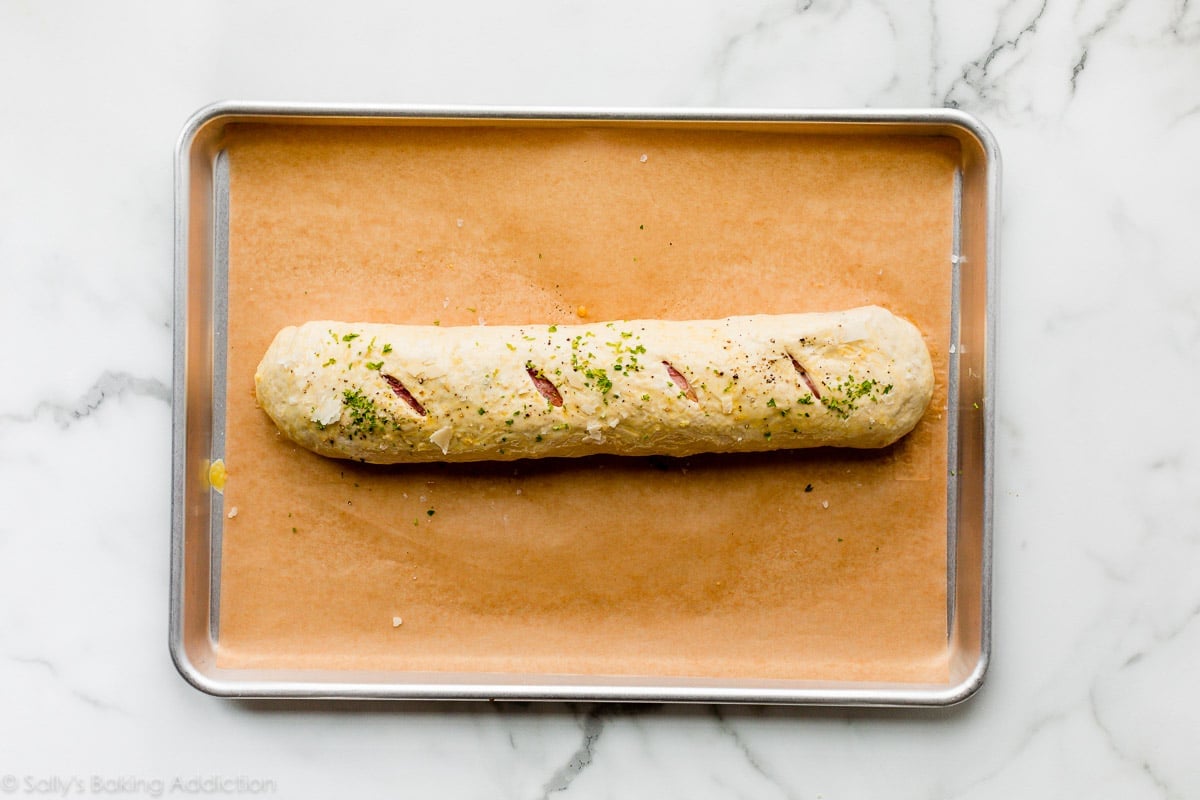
{"left": 208, "top": 121, "right": 961, "bottom": 684}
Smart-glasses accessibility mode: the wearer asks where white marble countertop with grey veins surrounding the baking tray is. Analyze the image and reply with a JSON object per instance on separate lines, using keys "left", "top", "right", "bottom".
{"left": 0, "top": 0, "right": 1200, "bottom": 800}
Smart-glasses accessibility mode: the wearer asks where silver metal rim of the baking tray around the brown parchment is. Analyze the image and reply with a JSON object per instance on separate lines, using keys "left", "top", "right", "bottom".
{"left": 168, "top": 102, "right": 1001, "bottom": 706}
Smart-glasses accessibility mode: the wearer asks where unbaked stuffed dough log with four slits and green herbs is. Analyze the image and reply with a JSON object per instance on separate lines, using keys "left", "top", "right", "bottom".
{"left": 254, "top": 306, "right": 934, "bottom": 464}
